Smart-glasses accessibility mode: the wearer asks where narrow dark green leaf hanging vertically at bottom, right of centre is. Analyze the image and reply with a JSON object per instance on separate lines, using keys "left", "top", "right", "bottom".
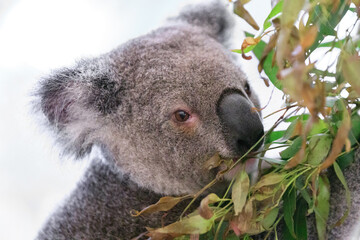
{"left": 283, "top": 187, "right": 296, "bottom": 238}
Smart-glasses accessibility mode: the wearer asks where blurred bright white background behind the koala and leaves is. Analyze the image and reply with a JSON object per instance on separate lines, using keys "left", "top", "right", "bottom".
{"left": 0, "top": 0, "right": 281, "bottom": 240}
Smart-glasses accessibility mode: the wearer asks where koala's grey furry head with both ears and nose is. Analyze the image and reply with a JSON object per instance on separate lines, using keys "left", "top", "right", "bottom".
{"left": 37, "top": 3, "right": 263, "bottom": 194}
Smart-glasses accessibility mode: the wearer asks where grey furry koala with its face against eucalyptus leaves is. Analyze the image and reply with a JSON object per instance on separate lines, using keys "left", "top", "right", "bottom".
{"left": 36, "top": 2, "right": 264, "bottom": 239}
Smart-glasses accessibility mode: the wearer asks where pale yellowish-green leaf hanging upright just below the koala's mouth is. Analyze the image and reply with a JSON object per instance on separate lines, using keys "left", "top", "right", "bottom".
{"left": 231, "top": 169, "right": 250, "bottom": 215}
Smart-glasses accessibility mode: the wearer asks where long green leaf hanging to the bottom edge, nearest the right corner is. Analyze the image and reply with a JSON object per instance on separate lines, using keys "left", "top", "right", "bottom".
{"left": 315, "top": 175, "right": 330, "bottom": 240}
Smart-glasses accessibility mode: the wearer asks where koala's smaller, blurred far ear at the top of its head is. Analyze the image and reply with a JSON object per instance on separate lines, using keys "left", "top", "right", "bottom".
{"left": 171, "top": 0, "right": 234, "bottom": 43}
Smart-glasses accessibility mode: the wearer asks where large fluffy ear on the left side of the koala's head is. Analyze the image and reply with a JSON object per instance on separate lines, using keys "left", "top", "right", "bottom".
{"left": 35, "top": 59, "right": 122, "bottom": 158}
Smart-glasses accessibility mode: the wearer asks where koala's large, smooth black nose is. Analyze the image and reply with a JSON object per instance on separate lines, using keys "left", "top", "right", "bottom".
{"left": 217, "top": 92, "right": 264, "bottom": 154}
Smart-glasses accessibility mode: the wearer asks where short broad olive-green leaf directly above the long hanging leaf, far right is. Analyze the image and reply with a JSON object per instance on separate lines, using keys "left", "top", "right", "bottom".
{"left": 307, "top": 134, "right": 333, "bottom": 166}
